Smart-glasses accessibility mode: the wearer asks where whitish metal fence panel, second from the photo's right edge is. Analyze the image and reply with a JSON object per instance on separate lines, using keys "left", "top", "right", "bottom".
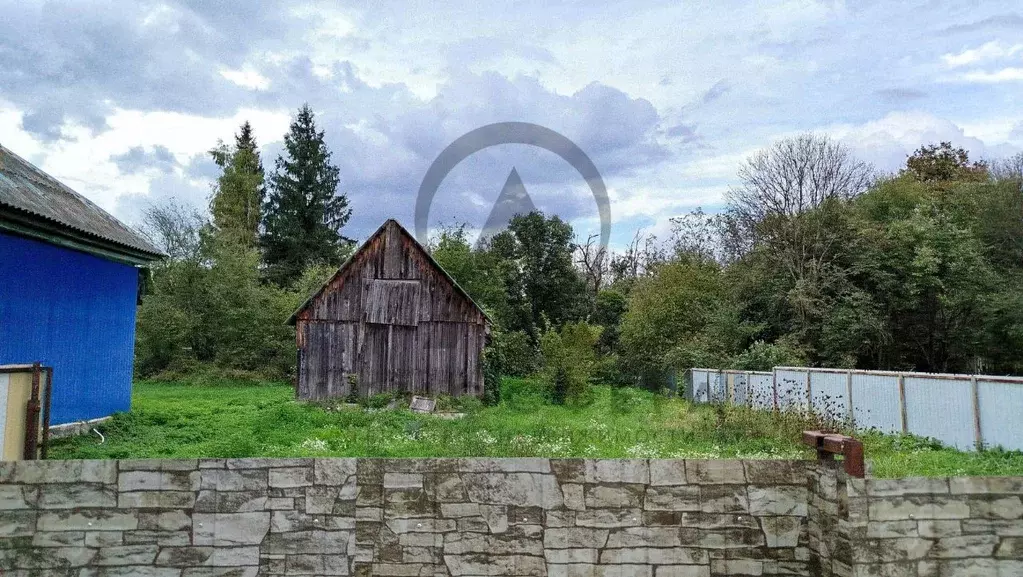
{"left": 902, "top": 374, "right": 977, "bottom": 449}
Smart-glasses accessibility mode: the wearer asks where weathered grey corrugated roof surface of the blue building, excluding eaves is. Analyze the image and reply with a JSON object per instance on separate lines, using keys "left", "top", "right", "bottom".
{"left": 0, "top": 145, "right": 163, "bottom": 257}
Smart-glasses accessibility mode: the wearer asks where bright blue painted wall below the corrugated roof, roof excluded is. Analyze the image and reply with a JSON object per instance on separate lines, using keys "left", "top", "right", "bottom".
{"left": 0, "top": 232, "right": 138, "bottom": 425}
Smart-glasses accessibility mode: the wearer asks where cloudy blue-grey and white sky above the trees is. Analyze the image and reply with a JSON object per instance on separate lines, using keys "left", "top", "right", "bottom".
{"left": 0, "top": 0, "right": 1023, "bottom": 245}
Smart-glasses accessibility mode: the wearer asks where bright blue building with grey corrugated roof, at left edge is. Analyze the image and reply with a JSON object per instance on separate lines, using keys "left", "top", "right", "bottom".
{"left": 0, "top": 146, "right": 162, "bottom": 425}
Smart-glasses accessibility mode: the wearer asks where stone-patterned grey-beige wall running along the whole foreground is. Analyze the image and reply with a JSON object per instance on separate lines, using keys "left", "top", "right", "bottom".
{"left": 0, "top": 458, "right": 1023, "bottom": 577}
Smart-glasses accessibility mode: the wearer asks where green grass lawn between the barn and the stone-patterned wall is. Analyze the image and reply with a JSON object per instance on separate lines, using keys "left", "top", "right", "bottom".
{"left": 50, "top": 379, "right": 1023, "bottom": 477}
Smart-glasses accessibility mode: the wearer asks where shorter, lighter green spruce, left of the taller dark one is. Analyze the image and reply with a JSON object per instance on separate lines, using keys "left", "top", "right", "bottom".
{"left": 210, "top": 122, "right": 264, "bottom": 247}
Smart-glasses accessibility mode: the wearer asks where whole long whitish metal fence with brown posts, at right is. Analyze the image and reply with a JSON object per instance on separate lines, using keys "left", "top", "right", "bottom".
{"left": 686, "top": 366, "right": 1023, "bottom": 450}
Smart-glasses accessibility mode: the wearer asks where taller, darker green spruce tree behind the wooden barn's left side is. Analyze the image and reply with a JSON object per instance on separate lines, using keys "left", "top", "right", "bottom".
{"left": 260, "top": 104, "right": 352, "bottom": 286}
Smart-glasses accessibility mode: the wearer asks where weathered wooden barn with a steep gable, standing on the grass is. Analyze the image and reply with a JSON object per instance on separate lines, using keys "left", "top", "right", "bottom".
{"left": 288, "top": 220, "right": 490, "bottom": 399}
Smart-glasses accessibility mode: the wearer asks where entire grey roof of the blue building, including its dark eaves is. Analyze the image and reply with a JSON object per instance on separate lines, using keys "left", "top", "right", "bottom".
{"left": 0, "top": 145, "right": 164, "bottom": 264}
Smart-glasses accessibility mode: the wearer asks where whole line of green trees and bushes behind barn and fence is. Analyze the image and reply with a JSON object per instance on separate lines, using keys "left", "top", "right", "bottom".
{"left": 137, "top": 118, "right": 1023, "bottom": 401}
